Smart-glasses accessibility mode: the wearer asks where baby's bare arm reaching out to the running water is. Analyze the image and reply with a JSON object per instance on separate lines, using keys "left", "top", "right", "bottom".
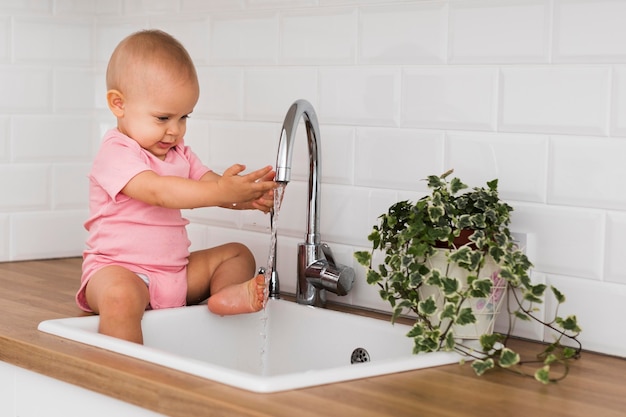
{"left": 122, "top": 165, "right": 276, "bottom": 211}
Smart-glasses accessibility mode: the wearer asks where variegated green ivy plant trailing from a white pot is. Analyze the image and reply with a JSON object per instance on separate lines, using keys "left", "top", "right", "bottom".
{"left": 355, "top": 170, "right": 582, "bottom": 384}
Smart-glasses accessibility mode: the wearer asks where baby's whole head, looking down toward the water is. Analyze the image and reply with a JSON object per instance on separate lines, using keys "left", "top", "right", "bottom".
{"left": 106, "top": 30, "right": 199, "bottom": 159}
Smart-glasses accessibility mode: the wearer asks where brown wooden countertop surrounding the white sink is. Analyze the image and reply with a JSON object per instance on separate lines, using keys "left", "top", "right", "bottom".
{"left": 0, "top": 258, "right": 626, "bottom": 417}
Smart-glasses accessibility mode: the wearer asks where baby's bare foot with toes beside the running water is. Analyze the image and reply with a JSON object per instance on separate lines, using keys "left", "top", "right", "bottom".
{"left": 207, "top": 275, "right": 265, "bottom": 316}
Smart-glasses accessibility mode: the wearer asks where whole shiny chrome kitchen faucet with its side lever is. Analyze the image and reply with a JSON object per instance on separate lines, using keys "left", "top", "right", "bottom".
{"left": 269, "top": 100, "right": 354, "bottom": 306}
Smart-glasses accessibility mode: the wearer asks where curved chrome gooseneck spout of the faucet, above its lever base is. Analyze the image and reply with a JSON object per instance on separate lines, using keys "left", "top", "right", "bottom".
{"left": 275, "top": 100, "right": 322, "bottom": 244}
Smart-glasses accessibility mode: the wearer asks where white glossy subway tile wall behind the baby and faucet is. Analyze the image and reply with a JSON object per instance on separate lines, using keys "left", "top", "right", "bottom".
{"left": 0, "top": 0, "right": 626, "bottom": 356}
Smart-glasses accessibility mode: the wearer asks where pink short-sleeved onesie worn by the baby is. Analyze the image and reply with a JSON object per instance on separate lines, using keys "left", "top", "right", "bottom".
{"left": 76, "top": 129, "right": 210, "bottom": 311}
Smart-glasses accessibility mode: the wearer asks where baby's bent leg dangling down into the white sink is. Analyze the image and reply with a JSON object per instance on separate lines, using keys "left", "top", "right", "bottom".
{"left": 85, "top": 265, "right": 150, "bottom": 343}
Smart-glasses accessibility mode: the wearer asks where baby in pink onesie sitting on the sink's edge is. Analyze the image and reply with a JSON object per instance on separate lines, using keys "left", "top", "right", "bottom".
{"left": 76, "top": 30, "right": 275, "bottom": 343}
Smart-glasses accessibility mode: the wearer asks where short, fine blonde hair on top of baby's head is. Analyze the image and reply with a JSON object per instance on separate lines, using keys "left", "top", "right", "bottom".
{"left": 106, "top": 30, "right": 198, "bottom": 94}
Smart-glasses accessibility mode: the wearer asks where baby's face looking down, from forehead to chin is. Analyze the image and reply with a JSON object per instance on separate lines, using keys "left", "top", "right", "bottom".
{"left": 118, "top": 72, "right": 199, "bottom": 159}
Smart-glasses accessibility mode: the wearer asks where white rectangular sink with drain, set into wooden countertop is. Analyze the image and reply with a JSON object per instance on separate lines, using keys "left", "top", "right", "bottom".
{"left": 39, "top": 300, "right": 461, "bottom": 392}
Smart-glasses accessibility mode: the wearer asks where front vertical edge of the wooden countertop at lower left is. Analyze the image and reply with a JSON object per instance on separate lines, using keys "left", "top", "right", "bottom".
{"left": 0, "top": 334, "right": 260, "bottom": 417}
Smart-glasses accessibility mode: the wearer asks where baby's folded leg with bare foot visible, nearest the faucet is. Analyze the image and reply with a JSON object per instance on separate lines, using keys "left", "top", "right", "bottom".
{"left": 187, "top": 243, "right": 265, "bottom": 315}
